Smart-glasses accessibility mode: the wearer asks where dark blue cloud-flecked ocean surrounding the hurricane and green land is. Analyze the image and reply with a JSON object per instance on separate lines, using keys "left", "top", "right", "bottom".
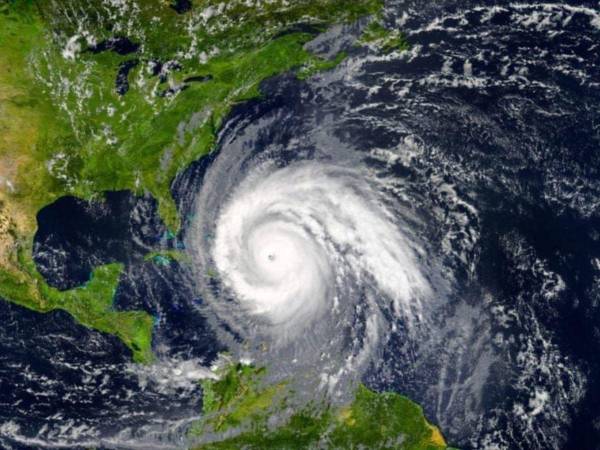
{"left": 0, "top": 1, "right": 600, "bottom": 449}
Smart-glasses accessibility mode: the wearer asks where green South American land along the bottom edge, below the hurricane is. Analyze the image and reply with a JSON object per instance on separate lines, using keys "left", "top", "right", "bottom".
{"left": 191, "top": 364, "right": 450, "bottom": 450}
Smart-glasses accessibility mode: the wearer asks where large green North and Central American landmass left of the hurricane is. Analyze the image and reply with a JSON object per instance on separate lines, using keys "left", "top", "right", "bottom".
{"left": 0, "top": 0, "right": 382, "bottom": 361}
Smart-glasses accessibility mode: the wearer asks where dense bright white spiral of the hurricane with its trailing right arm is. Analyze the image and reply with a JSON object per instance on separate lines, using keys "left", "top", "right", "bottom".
{"left": 212, "top": 163, "right": 429, "bottom": 333}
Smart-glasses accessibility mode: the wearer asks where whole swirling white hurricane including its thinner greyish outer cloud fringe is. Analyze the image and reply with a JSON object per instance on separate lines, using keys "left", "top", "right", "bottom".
{"left": 188, "top": 150, "right": 436, "bottom": 394}
